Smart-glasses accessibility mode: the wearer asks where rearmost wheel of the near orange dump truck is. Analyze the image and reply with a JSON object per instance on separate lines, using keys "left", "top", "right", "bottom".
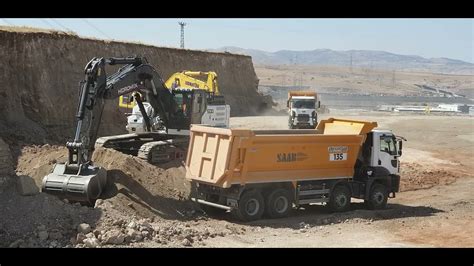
{"left": 232, "top": 190, "right": 265, "bottom": 222}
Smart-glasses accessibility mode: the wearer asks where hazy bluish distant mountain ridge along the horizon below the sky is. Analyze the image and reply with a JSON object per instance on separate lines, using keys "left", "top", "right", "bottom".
{"left": 209, "top": 46, "right": 474, "bottom": 75}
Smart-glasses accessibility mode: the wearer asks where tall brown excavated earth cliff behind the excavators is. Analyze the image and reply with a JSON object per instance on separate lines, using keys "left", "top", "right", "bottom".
{"left": 0, "top": 27, "right": 271, "bottom": 144}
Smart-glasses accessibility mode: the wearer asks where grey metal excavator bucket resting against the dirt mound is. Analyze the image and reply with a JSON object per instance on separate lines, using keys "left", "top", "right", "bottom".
{"left": 41, "top": 164, "right": 107, "bottom": 204}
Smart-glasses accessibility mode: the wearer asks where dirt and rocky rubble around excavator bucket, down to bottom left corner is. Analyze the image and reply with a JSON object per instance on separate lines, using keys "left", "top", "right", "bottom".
{"left": 0, "top": 144, "right": 235, "bottom": 247}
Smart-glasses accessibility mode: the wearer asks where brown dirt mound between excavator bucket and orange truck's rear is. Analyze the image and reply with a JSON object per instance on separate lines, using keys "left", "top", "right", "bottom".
{"left": 93, "top": 148, "right": 190, "bottom": 218}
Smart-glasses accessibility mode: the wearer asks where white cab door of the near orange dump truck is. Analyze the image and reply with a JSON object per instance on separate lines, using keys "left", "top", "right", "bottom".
{"left": 377, "top": 135, "right": 398, "bottom": 174}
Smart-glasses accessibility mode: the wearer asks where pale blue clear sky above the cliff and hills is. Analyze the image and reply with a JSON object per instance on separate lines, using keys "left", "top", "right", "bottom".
{"left": 0, "top": 18, "right": 474, "bottom": 63}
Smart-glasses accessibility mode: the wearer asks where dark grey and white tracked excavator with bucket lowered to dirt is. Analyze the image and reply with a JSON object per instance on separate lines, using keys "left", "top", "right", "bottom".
{"left": 42, "top": 57, "right": 231, "bottom": 204}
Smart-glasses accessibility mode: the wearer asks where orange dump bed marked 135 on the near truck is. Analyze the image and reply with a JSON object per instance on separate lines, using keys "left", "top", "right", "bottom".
{"left": 186, "top": 118, "right": 377, "bottom": 188}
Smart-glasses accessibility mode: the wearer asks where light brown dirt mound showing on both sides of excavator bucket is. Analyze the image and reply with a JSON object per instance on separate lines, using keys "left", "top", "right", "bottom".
{"left": 16, "top": 144, "right": 190, "bottom": 219}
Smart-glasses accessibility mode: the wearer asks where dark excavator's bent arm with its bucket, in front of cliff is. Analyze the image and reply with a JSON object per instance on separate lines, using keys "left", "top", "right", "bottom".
{"left": 42, "top": 57, "right": 177, "bottom": 202}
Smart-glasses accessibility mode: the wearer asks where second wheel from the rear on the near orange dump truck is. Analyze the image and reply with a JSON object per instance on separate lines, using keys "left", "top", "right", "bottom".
{"left": 265, "top": 188, "right": 293, "bottom": 219}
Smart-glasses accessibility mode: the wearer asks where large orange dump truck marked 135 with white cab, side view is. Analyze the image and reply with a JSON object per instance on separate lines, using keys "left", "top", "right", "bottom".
{"left": 185, "top": 118, "right": 404, "bottom": 221}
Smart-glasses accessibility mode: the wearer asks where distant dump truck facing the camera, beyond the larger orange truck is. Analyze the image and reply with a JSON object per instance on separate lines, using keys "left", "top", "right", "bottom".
{"left": 287, "top": 91, "right": 320, "bottom": 129}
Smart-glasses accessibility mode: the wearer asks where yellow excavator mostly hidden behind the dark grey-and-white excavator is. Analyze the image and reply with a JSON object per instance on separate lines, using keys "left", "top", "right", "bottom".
{"left": 119, "top": 71, "right": 220, "bottom": 109}
